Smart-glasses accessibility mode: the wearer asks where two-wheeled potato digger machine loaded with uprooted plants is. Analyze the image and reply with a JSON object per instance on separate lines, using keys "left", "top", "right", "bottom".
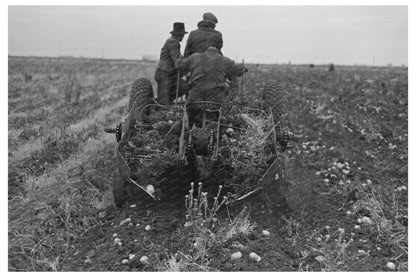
{"left": 105, "top": 78, "right": 296, "bottom": 206}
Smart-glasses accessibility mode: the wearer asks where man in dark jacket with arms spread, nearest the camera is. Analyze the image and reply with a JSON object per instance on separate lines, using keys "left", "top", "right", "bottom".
{"left": 175, "top": 46, "right": 247, "bottom": 126}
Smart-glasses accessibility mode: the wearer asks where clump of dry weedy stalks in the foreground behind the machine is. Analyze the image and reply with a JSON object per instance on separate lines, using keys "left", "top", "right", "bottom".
{"left": 170, "top": 183, "right": 257, "bottom": 271}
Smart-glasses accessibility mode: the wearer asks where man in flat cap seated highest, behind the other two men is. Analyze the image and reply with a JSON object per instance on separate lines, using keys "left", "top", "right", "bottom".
{"left": 184, "top": 12, "right": 223, "bottom": 57}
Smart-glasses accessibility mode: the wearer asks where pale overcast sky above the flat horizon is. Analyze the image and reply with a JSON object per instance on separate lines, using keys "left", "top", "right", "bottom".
{"left": 8, "top": 6, "right": 408, "bottom": 65}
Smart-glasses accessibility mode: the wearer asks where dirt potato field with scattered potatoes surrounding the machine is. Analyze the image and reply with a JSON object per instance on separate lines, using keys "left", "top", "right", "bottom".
{"left": 8, "top": 57, "right": 408, "bottom": 271}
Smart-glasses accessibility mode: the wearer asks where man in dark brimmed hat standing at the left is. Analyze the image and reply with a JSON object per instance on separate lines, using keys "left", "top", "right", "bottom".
{"left": 155, "top": 22, "right": 189, "bottom": 105}
